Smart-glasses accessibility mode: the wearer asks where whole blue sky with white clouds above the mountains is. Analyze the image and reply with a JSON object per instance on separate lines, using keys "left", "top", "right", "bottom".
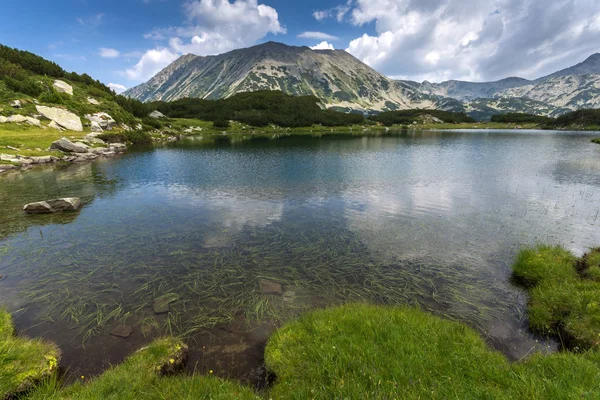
{"left": 0, "top": 0, "right": 600, "bottom": 92}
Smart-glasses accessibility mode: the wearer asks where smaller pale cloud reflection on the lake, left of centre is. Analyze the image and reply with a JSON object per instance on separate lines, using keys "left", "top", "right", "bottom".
{"left": 158, "top": 185, "right": 283, "bottom": 247}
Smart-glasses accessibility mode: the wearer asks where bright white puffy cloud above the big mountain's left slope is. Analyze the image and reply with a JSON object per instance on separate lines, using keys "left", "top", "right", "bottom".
{"left": 127, "top": 0, "right": 287, "bottom": 80}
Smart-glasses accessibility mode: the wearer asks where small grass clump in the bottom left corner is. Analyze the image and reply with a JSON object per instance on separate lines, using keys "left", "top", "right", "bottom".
{"left": 0, "top": 309, "right": 60, "bottom": 399}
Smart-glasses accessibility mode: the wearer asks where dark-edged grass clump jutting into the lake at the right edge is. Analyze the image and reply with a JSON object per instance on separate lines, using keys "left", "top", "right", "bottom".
{"left": 513, "top": 246, "right": 600, "bottom": 350}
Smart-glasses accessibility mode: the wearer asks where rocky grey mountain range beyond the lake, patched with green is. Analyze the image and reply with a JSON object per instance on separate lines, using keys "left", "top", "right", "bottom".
{"left": 125, "top": 42, "right": 600, "bottom": 119}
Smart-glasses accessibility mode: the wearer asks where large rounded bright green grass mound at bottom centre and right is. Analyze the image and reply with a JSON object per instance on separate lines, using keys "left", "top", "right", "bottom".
{"left": 266, "top": 305, "right": 600, "bottom": 399}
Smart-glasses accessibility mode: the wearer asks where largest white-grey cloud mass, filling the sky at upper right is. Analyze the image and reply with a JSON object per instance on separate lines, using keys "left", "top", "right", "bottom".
{"left": 340, "top": 0, "right": 600, "bottom": 80}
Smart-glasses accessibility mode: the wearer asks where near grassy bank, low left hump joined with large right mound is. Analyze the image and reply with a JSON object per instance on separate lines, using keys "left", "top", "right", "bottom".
{"left": 4, "top": 304, "right": 600, "bottom": 400}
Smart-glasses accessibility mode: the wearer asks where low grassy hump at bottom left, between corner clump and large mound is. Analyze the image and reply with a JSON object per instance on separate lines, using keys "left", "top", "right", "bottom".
{"left": 29, "top": 338, "right": 257, "bottom": 400}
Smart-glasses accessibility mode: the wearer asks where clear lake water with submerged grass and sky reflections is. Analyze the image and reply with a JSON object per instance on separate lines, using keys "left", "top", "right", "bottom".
{"left": 0, "top": 131, "right": 600, "bottom": 383}
